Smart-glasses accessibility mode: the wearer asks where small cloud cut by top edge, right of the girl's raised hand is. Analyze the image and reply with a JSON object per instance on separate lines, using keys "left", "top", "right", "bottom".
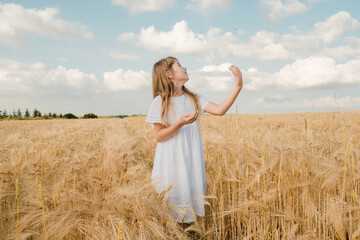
{"left": 260, "top": 0, "right": 308, "bottom": 20}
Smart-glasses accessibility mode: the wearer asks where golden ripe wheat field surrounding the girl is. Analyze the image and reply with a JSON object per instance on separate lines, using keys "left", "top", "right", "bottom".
{"left": 0, "top": 111, "right": 360, "bottom": 239}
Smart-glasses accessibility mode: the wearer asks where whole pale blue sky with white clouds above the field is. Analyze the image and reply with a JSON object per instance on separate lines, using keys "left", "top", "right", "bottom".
{"left": 0, "top": 0, "right": 360, "bottom": 116}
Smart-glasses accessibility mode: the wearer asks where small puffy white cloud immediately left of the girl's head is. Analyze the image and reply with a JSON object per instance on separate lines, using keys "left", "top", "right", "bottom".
{"left": 104, "top": 68, "right": 151, "bottom": 91}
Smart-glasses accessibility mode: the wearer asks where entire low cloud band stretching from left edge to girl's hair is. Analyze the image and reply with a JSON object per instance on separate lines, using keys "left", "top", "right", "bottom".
{"left": 0, "top": 58, "right": 151, "bottom": 94}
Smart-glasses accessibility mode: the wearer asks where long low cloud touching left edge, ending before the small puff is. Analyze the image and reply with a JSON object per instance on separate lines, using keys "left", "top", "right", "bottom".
{"left": 0, "top": 58, "right": 101, "bottom": 92}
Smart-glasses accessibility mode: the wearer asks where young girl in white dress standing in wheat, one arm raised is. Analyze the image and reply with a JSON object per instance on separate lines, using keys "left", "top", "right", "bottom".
{"left": 145, "top": 57, "right": 242, "bottom": 223}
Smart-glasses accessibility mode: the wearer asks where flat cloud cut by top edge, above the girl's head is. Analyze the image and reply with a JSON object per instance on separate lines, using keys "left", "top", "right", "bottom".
{"left": 112, "top": 0, "right": 175, "bottom": 14}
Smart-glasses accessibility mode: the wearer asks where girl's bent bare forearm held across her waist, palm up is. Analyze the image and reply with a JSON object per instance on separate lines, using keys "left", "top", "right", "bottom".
{"left": 154, "top": 111, "right": 199, "bottom": 142}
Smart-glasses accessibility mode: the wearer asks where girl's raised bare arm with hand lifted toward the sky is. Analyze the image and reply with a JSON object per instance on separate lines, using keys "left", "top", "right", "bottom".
{"left": 204, "top": 65, "right": 243, "bottom": 116}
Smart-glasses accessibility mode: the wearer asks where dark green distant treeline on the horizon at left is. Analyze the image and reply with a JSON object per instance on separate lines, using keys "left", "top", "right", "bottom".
{"left": 0, "top": 108, "right": 143, "bottom": 120}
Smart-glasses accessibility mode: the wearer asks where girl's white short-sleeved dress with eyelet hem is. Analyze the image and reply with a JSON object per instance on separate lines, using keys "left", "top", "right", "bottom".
{"left": 145, "top": 94, "right": 209, "bottom": 222}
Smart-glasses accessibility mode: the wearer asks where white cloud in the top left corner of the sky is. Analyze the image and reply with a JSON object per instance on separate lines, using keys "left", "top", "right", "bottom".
{"left": 0, "top": 2, "right": 93, "bottom": 47}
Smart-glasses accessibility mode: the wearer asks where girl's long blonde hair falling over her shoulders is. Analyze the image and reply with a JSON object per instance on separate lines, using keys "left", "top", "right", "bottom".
{"left": 152, "top": 57, "right": 200, "bottom": 125}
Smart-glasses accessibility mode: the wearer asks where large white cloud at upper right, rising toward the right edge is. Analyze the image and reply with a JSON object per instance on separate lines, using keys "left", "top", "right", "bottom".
{"left": 248, "top": 12, "right": 360, "bottom": 60}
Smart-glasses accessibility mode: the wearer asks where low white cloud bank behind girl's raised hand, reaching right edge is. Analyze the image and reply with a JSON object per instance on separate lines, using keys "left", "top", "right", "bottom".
{"left": 188, "top": 57, "right": 360, "bottom": 92}
